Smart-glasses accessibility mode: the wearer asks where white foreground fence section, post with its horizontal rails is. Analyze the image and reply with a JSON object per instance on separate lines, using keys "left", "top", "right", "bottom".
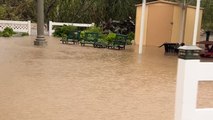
{"left": 175, "top": 59, "right": 213, "bottom": 120}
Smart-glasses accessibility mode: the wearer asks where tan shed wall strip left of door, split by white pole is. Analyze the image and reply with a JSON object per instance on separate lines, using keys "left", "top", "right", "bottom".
{"left": 135, "top": 6, "right": 149, "bottom": 45}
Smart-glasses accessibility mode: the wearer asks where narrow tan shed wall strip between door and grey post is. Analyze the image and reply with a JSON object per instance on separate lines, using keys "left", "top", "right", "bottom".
{"left": 171, "top": 6, "right": 181, "bottom": 43}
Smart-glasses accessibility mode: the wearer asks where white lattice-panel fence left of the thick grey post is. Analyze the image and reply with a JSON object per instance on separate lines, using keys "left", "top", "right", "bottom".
{"left": 0, "top": 20, "right": 31, "bottom": 35}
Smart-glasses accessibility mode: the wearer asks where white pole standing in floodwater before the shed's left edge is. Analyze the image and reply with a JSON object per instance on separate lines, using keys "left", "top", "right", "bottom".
{"left": 139, "top": 0, "right": 146, "bottom": 54}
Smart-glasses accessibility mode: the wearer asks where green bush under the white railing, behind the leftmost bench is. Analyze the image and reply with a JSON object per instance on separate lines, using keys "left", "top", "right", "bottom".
{"left": 53, "top": 25, "right": 77, "bottom": 37}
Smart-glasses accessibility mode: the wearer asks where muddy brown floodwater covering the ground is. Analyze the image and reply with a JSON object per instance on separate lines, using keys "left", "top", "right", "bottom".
{"left": 0, "top": 37, "right": 211, "bottom": 120}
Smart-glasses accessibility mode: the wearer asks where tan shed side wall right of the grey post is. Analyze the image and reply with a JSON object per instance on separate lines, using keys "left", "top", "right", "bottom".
{"left": 184, "top": 8, "right": 202, "bottom": 45}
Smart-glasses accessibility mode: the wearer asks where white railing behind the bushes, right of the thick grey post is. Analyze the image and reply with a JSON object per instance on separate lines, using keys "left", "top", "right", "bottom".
{"left": 49, "top": 21, "right": 95, "bottom": 36}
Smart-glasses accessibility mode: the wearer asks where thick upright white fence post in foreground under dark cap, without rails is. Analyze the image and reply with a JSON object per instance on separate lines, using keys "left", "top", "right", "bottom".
{"left": 175, "top": 59, "right": 200, "bottom": 120}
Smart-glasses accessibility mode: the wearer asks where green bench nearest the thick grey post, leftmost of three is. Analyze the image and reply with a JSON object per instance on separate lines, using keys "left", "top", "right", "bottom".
{"left": 61, "top": 31, "right": 81, "bottom": 44}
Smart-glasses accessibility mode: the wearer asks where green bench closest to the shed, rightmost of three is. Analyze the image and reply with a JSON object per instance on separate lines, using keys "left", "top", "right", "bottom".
{"left": 107, "top": 34, "right": 128, "bottom": 50}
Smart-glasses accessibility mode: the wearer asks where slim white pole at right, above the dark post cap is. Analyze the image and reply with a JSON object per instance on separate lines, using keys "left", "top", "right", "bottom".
{"left": 192, "top": 0, "right": 201, "bottom": 45}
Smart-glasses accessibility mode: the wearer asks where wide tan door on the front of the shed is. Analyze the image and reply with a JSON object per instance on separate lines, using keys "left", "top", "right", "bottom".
{"left": 146, "top": 3, "right": 174, "bottom": 46}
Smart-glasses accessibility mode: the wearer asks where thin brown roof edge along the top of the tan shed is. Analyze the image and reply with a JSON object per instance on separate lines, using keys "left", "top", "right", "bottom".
{"left": 135, "top": 0, "right": 204, "bottom": 10}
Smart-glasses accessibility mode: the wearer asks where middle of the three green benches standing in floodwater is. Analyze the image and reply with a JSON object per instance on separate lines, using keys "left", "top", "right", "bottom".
{"left": 80, "top": 32, "right": 99, "bottom": 46}
